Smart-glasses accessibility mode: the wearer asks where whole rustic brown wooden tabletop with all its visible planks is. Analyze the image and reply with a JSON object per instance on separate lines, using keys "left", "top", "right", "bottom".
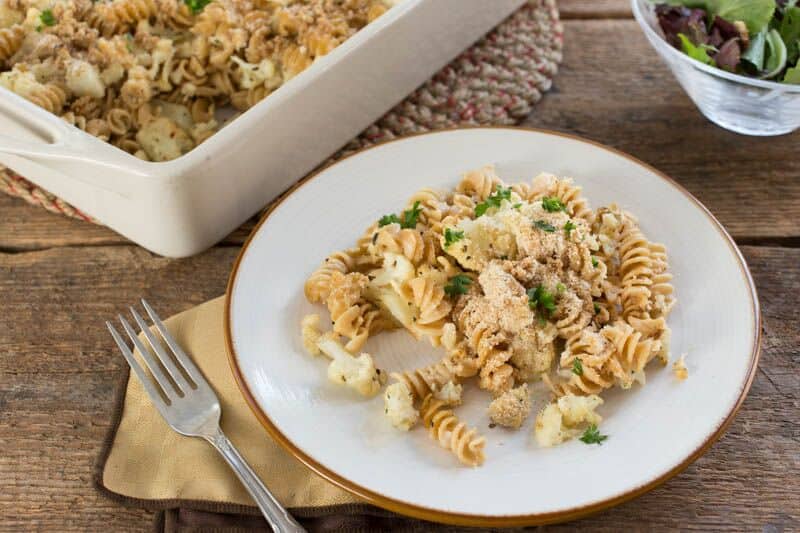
{"left": 0, "top": 0, "right": 800, "bottom": 531}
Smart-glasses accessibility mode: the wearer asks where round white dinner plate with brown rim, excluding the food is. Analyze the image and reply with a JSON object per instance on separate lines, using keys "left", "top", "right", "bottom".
{"left": 225, "top": 128, "right": 761, "bottom": 526}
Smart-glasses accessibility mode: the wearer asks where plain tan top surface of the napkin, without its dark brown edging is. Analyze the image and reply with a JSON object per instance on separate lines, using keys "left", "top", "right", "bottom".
{"left": 99, "top": 297, "right": 362, "bottom": 508}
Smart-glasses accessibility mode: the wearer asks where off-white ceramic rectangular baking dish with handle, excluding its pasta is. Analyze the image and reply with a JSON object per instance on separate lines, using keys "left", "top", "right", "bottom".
{"left": 0, "top": 0, "right": 524, "bottom": 257}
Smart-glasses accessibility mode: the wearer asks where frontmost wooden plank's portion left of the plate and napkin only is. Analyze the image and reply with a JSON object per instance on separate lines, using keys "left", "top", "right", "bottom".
{"left": 0, "top": 246, "right": 238, "bottom": 531}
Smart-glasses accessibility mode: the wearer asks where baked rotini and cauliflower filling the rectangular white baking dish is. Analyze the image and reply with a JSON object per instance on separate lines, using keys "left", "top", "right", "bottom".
{"left": 0, "top": 0, "right": 397, "bottom": 161}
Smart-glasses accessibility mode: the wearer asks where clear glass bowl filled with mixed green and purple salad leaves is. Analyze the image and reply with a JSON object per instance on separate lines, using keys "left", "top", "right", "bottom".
{"left": 631, "top": 0, "right": 800, "bottom": 135}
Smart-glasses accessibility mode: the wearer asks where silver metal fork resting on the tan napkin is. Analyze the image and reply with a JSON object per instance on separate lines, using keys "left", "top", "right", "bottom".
{"left": 106, "top": 299, "right": 305, "bottom": 532}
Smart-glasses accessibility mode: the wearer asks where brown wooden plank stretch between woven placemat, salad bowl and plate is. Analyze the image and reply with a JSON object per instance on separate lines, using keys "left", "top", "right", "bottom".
{"left": 526, "top": 20, "right": 800, "bottom": 242}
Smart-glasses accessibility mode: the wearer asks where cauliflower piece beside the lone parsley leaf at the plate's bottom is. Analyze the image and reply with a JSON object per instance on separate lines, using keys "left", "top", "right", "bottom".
{"left": 534, "top": 394, "right": 603, "bottom": 448}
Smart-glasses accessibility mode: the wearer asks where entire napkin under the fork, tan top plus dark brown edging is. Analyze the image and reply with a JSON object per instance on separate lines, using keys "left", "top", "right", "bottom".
{"left": 94, "top": 298, "right": 488, "bottom": 533}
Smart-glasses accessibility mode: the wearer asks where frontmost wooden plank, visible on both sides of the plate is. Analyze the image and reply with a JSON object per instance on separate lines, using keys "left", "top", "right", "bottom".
{"left": 0, "top": 246, "right": 800, "bottom": 532}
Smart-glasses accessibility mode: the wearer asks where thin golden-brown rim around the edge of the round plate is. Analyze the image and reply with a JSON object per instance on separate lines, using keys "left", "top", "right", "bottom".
{"left": 223, "top": 126, "right": 761, "bottom": 527}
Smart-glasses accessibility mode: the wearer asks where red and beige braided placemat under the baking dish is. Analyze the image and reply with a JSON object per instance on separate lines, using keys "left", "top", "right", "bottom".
{"left": 0, "top": 0, "right": 563, "bottom": 223}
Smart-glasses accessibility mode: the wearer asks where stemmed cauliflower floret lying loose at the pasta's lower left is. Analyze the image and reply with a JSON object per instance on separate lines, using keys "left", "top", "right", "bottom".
{"left": 317, "top": 333, "right": 386, "bottom": 396}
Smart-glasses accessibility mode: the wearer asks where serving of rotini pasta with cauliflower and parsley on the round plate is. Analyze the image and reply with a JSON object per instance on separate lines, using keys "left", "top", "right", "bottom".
{"left": 303, "top": 167, "right": 675, "bottom": 466}
